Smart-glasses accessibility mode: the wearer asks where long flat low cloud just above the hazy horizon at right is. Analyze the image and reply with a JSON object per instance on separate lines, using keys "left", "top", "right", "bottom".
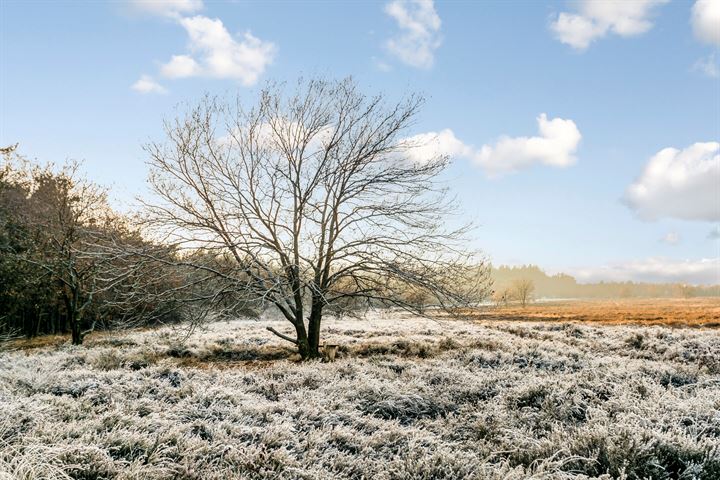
{"left": 569, "top": 258, "right": 720, "bottom": 285}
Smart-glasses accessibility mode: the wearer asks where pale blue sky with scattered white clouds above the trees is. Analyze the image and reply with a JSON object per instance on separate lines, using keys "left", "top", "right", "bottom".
{"left": 0, "top": 0, "right": 720, "bottom": 283}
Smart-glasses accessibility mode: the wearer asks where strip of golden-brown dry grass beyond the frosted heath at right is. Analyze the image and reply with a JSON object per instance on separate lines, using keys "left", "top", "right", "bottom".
{"left": 461, "top": 298, "right": 720, "bottom": 328}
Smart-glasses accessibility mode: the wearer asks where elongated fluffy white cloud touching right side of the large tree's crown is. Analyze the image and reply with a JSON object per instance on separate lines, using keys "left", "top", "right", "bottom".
{"left": 396, "top": 113, "right": 582, "bottom": 176}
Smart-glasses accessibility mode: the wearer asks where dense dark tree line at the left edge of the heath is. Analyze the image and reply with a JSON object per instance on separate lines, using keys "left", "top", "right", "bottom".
{"left": 0, "top": 159, "right": 177, "bottom": 344}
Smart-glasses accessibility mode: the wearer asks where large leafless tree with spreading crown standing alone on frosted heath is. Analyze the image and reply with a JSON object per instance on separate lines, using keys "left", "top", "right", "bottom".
{"left": 146, "top": 79, "right": 488, "bottom": 358}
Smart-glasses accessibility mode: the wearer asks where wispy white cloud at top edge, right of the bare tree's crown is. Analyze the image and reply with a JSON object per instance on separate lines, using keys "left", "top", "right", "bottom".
{"left": 385, "top": 0, "right": 442, "bottom": 68}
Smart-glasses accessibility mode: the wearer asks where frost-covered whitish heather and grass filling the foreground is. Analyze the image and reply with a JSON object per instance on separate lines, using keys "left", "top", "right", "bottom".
{"left": 0, "top": 314, "right": 720, "bottom": 480}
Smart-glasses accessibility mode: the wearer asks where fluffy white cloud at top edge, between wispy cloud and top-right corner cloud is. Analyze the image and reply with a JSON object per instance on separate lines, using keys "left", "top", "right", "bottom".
{"left": 550, "top": 0, "right": 668, "bottom": 50}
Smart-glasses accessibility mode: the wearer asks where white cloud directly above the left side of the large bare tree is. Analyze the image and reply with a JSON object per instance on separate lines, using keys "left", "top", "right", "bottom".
{"left": 161, "top": 15, "right": 277, "bottom": 86}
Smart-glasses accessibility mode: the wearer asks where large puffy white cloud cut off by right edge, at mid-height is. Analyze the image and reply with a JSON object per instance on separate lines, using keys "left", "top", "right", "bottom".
{"left": 624, "top": 142, "right": 720, "bottom": 221}
